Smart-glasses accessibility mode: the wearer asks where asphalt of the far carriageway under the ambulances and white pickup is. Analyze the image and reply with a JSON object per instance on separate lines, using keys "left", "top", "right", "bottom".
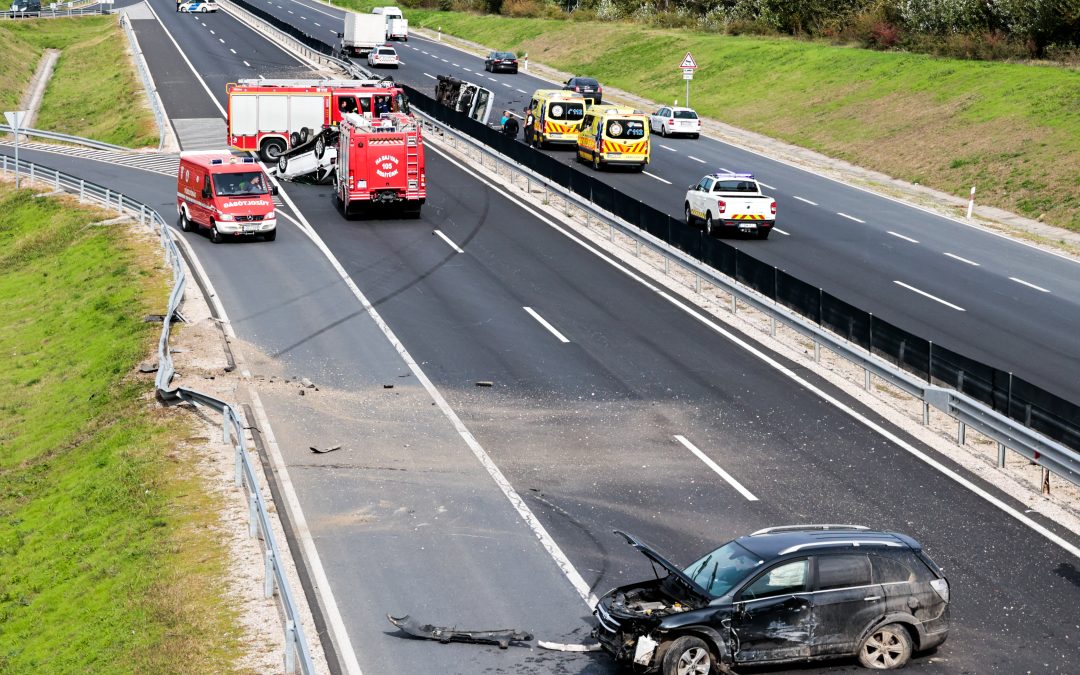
{"left": 243, "top": 0, "right": 1080, "bottom": 401}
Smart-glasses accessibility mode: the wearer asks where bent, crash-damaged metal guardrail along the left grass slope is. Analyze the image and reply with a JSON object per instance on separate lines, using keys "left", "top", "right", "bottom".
{"left": 0, "top": 154, "right": 315, "bottom": 675}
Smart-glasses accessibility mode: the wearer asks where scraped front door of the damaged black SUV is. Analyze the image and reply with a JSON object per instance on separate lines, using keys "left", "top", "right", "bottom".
{"left": 731, "top": 558, "right": 813, "bottom": 663}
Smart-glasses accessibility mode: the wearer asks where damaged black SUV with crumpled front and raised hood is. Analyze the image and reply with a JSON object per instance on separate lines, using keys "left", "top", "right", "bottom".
{"left": 593, "top": 525, "right": 949, "bottom": 675}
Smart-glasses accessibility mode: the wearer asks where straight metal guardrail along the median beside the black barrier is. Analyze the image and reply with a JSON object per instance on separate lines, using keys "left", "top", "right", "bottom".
{"left": 414, "top": 107, "right": 1080, "bottom": 485}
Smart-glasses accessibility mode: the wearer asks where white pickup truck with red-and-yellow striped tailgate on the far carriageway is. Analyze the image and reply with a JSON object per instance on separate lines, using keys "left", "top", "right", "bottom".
{"left": 683, "top": 172, "right": 777, "bottom": 239}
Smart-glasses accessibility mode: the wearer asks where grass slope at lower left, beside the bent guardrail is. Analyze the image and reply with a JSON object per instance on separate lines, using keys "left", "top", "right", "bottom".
{"left": 0, "top": 184, "right": 237, "bottom": 674}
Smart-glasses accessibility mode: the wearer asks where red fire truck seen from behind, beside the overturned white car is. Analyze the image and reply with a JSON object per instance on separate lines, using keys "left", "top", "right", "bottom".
{"left": 334, "top": 112, "right": 428, "bottom": 218}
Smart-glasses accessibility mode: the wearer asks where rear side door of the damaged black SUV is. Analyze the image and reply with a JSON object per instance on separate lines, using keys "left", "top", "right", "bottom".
{"left": 810, "top": 554, "right": 886, "bottom": 657}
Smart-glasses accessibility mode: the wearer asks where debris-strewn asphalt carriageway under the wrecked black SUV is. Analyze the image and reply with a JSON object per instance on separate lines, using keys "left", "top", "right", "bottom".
{"left": 2, "top": 0, "right": 1080, "bottom": 673}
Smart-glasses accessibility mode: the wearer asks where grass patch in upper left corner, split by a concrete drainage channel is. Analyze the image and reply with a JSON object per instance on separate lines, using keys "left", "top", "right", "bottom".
{"left": 0, "top": 16, "right": 158, "bottom": 148}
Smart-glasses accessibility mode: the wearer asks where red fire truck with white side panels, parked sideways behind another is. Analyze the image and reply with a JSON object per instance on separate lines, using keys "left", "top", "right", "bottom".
{"left": 226, "top": 79, "right": 408, "bottom": 162}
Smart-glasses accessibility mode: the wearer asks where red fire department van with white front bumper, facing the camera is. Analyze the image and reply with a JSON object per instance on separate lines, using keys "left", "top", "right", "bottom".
{"left": 176, "top": 150, "right": 278, "bottom": 244}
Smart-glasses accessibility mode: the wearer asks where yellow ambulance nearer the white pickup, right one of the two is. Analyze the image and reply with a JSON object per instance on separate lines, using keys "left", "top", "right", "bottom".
{"left": 578, "top": 105, "right": 651, "bottom": 171}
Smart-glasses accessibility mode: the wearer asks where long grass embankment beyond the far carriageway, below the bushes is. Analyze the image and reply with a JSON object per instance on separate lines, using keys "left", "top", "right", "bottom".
{"left": 345, "top": 5, "right": 1080, "bottom": 231}
